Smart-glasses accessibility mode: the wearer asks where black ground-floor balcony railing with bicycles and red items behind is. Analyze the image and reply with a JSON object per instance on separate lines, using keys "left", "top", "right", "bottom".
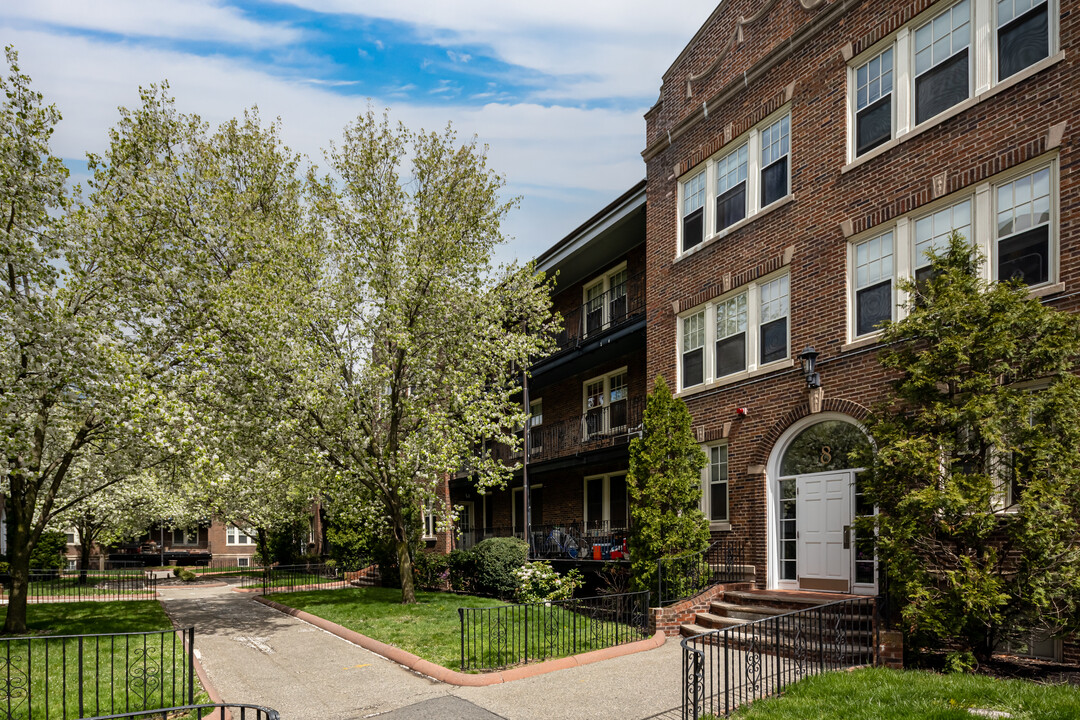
{"left": 457, "top": 521, "right": 630, "bottom": 561}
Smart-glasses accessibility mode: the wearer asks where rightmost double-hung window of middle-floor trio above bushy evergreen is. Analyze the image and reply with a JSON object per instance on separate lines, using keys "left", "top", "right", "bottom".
{"left": 996, "top": 167, "right": 1050, "bottom": 285}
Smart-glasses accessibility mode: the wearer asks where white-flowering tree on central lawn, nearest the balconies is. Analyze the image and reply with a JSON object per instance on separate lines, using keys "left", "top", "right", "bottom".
{"left": 232, "top": 111, "right": 553, "bottom": 602}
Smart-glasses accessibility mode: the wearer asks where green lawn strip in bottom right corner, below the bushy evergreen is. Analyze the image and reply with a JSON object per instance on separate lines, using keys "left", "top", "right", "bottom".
{"left": 731, "top": 668, "right": 1080, "bottom": 720}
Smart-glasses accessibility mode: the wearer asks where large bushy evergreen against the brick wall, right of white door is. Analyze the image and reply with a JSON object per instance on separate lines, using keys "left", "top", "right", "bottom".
{"left": 865, "top": 233, "right": 1080, "bottom": 665}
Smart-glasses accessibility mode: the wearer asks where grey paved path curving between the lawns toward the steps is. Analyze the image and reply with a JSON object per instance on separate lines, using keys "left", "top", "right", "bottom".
{"left": 160, "top": 587, "right": 680, "bottom": 720}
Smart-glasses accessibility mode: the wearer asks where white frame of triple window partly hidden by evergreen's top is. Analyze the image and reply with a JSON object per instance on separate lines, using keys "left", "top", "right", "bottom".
{"left": 842, "top": 152, "right": 1061, "bottom": 343}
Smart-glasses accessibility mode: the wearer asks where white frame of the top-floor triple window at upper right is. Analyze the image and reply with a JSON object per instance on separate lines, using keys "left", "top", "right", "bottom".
{"left": 847, "top": 0, "right": 1061, "bottom": 163}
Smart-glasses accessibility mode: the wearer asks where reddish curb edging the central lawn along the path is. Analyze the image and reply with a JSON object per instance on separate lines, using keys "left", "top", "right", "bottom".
{"left": 253, "top": 596, "right": 667, "bottom": 688}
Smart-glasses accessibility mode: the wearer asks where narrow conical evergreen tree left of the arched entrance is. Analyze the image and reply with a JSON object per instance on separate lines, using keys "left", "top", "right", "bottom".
{"left": 626, "top": 376, "right": 708, "bottom": 590}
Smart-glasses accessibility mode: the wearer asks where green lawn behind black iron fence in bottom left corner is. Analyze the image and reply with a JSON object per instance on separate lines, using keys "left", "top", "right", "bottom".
{"left": 0, "top": 600, "right": 206, "bottom": 720}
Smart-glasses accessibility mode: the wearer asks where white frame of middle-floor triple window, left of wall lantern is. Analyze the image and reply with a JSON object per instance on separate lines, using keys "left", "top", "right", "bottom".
{"left": 675, "top": 268, "right": 792, "bottom": 393}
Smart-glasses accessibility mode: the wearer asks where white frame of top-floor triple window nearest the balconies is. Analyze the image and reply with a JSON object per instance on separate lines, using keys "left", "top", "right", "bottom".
{"left": 675, "top": 105, "right": 795, "bottom": 254}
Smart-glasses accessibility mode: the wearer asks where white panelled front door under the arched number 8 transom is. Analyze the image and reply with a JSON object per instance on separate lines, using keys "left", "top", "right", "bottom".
{"left": 796, "top": 472, "right": 853, "bottom": 593}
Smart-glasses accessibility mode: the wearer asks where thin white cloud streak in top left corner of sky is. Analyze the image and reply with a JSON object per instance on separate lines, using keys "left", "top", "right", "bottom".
{"left": 4, "top": 0, "right": 300, "bottom": 46}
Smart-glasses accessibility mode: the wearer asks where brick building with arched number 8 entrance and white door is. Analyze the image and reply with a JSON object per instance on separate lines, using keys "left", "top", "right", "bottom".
{"left": 643, "top": 0, "right": 1080, "bottom": 660}
